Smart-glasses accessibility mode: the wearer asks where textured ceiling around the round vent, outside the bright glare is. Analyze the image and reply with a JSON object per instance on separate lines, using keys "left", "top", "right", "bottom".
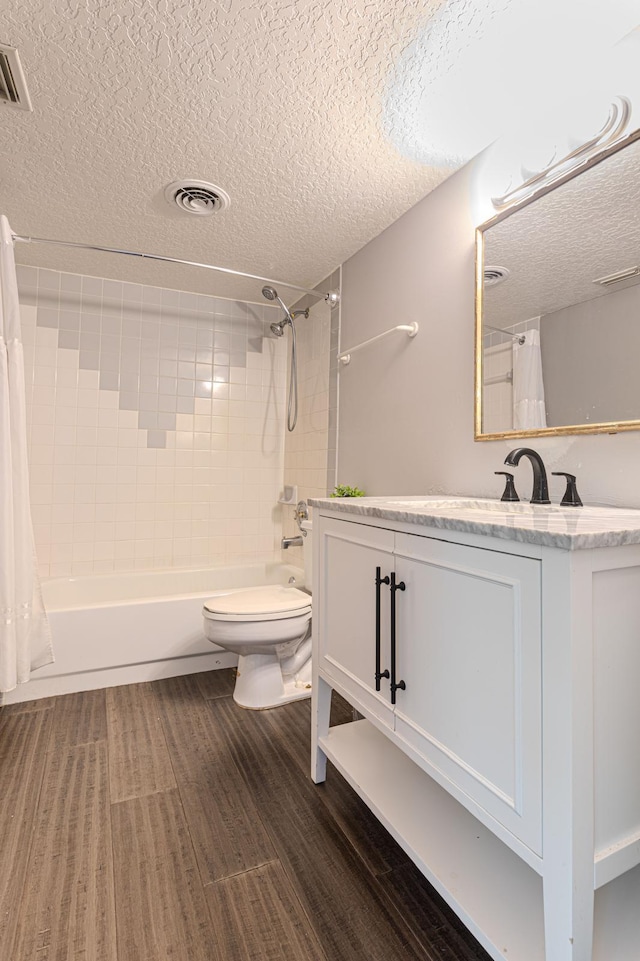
{"left": 0, "top": 0, "right": 456, "bottom": 300}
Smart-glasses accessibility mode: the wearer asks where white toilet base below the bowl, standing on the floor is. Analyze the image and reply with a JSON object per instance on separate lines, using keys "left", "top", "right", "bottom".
{"left": 233, "top": 654, "right": 311, "bottom": 711}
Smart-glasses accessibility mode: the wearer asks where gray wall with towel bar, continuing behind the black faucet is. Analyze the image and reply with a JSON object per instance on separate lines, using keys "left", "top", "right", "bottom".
{"left": 338, "top": 158, "right": 640, "bottom": 507}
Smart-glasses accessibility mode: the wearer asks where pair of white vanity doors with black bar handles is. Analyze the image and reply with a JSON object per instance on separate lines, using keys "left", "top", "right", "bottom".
{"left": 314, "top": 518, "right": 541, "bottom": 855}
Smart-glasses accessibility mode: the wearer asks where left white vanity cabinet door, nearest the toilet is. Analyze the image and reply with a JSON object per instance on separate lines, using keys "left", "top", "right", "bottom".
{"left": 313, "top": 518, "right": 394, "bottom": 728}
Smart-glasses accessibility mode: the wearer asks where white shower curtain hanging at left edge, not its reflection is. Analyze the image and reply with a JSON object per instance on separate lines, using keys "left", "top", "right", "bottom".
{"left": 0, "top": 216, "right": 53, "bottom": 693}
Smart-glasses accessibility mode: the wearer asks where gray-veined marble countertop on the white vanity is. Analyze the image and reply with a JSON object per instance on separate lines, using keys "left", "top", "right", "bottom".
{"left": 309, "top": 495, "right": 640, "bottom": 550}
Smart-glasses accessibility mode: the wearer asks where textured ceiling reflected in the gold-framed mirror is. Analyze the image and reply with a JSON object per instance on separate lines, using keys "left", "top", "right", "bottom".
{"left": 485, "top": 132, "right": 640, "bottom": 327}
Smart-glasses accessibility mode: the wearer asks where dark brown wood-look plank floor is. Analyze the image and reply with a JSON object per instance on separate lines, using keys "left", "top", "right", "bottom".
{"left": 0, "top": 671, "right": 488, "bottom": 961}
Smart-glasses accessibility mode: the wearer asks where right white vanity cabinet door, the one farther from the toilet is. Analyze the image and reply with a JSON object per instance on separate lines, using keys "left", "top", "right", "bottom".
{"left": 395, "top": 534, "right": 541, "bottom": 854}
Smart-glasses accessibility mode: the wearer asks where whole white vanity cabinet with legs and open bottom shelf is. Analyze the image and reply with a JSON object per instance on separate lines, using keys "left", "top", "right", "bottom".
{"left": 312, "top": 499, "right": 640, "bottom": 961}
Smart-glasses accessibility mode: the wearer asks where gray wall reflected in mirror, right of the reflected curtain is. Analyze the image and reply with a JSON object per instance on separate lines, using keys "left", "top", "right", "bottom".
{"left": 540, "top": 286, "right": 640, "bottom": 427}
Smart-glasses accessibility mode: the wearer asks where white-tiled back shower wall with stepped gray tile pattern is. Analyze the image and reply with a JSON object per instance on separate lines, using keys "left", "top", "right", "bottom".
{"left": 18, "top": 267, "right": 286, "bottom": 576}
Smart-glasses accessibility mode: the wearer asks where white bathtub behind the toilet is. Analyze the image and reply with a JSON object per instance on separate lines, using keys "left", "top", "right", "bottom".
{"left": 3, "top": 563, "right": 303, "bottom": 704}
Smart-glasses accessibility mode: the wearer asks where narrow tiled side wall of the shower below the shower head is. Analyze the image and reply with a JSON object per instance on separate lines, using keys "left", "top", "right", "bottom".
{"left": 283, "top": 271, "right": 340, "bottom": 563}
